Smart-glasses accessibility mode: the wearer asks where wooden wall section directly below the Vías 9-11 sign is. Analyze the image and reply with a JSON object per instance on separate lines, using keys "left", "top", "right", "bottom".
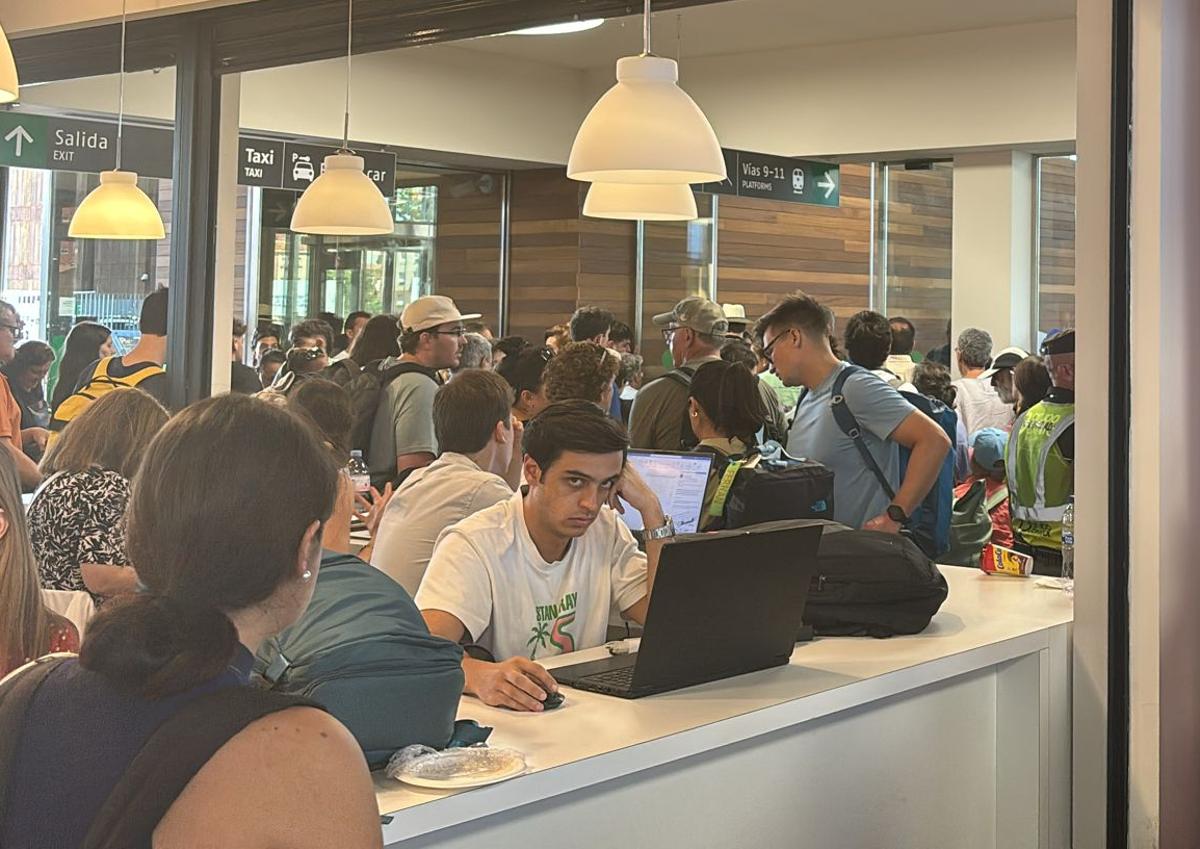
{"left": 716, "top": 165, "right": 871, "bottom": 338}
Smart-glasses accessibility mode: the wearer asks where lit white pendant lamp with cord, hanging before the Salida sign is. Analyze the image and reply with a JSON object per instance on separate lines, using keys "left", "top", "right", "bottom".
{"left": 67, "top": 0, "right": 167, "bottom": 239}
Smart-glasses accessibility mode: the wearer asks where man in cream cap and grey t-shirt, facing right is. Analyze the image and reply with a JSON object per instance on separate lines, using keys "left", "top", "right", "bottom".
{"left": 366, "top": 295, "right": 480, "bottom": 486}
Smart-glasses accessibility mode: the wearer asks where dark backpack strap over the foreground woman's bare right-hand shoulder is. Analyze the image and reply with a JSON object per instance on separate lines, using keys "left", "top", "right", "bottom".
{"left": 83, "top": 686, "right": 324, "bottom": 849}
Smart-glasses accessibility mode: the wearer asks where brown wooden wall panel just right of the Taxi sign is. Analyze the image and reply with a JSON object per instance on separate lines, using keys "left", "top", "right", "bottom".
{"left": 433, "top": 174, "right": 503, "bottom": 331}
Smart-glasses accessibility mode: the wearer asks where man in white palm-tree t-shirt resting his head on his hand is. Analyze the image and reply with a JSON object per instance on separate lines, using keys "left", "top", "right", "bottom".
{"left": 416, "top": 401, "right": 674, "bottom": 711}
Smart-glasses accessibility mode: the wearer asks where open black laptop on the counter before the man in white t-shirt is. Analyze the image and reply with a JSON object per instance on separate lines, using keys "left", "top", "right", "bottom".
{"left": 551, "top": 525, "right": 821, "bottom": 699}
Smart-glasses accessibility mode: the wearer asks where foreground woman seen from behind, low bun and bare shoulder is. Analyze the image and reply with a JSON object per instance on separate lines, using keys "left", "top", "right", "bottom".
{"left": 0, "top": 395, "right": 382, "bottom": 849}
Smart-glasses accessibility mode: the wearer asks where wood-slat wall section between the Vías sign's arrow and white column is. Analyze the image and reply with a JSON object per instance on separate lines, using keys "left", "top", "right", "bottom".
{"left": 887, "top": 163, "right": 954, "bottom": 354}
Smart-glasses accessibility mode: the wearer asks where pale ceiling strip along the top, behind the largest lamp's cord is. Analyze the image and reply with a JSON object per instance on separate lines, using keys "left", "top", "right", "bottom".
{"left": 455, "top": 0, "right": 1075, "bottom": 68}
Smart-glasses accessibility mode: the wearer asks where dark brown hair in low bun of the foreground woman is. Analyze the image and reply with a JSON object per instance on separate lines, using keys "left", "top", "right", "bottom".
{"left": 79, "top": 393, "right": 338, "bottom": 699}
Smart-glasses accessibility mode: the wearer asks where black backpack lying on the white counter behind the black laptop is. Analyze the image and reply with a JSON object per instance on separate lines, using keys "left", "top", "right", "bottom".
{"left": 804, "top": 523, "right": 950, "bottom": 637}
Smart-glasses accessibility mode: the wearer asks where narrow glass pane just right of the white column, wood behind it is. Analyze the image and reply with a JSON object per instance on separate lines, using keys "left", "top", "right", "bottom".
{"left": 1034, "top": 156, "right": 1075, "bottom": 344}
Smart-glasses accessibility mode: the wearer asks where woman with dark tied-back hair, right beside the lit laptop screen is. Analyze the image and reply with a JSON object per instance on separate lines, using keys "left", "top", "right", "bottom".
{"left": 688, "top": 360, "right": 768, "bottom": 530}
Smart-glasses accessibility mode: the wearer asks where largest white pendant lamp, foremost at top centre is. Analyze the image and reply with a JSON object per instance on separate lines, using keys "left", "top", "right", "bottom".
{"left": 566, "top": 0, "right": 725, "bottom": 185}
